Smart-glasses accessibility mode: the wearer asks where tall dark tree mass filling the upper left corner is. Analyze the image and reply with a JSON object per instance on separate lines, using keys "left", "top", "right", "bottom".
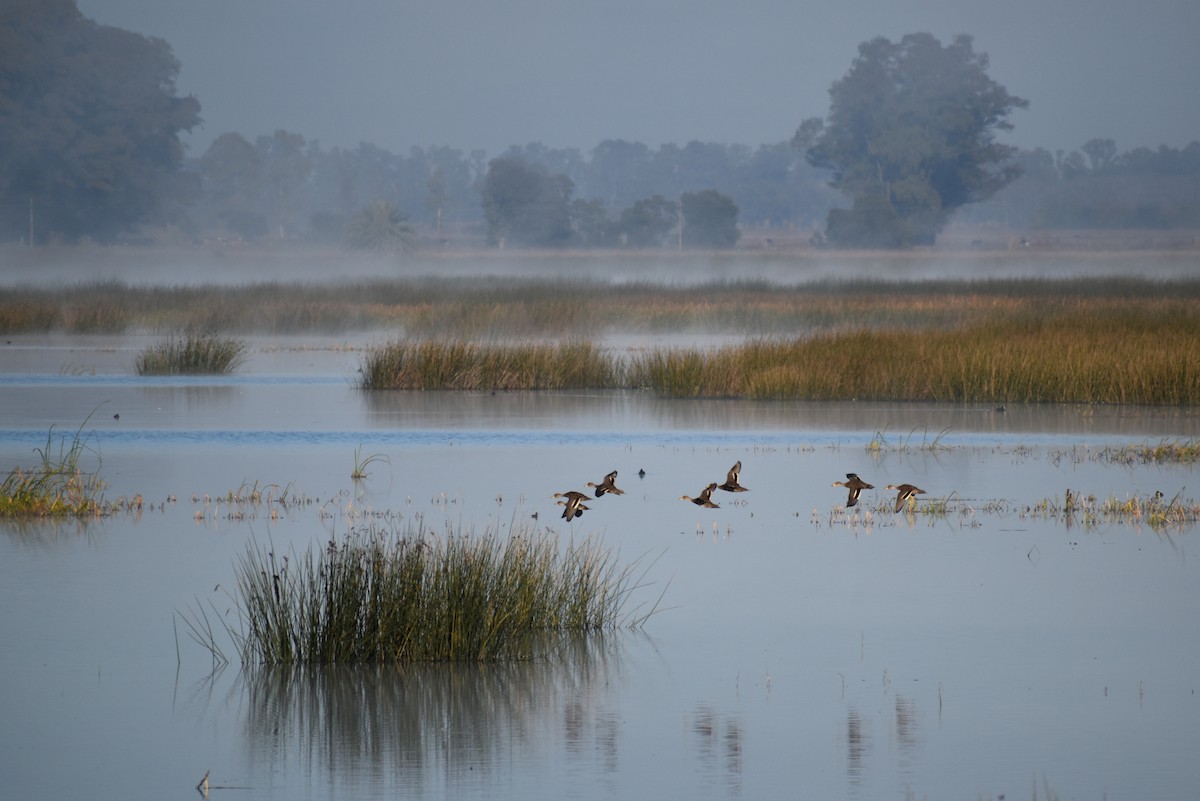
{"left": 0, "top": 0, "right": 200, "bottom": 240}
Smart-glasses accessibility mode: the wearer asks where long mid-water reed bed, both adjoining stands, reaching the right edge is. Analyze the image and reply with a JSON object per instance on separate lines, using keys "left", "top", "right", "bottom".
{"left": 359, "top": 311, "right": 1200, "bottom": 402}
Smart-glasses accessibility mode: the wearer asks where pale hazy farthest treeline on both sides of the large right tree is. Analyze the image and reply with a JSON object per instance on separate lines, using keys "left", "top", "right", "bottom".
{"left": 186, "top": 131, "right": 1200, "bottom": 245}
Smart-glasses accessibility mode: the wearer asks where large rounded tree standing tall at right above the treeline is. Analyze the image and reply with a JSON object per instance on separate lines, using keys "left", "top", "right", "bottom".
{"left": 793, "top": 34, "right": 1028, "bottom": 247}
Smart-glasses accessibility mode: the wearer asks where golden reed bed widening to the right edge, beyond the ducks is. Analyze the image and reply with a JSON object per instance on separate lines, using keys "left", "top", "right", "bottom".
{"left": 628, "top": 308, "right": 1200, "bottom": 405}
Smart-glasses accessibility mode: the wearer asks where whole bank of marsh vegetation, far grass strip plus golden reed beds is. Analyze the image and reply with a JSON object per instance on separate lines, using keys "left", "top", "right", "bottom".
{"left": 0, "top": 275, "right": 1200, "bottom": 405}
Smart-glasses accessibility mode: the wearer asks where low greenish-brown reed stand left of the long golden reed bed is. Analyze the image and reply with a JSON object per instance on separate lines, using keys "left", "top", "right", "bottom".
{"left": 359, "top": 339, "right": 623, "bottom": 391}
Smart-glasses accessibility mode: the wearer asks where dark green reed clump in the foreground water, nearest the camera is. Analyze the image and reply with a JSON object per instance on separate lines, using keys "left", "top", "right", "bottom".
{"left": 202, "top": 523, "right": 654, "bottom": 664}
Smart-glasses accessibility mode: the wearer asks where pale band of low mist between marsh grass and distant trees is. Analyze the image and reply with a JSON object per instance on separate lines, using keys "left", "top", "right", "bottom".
{"left": 0, "top": 247, "right": 1200, "bottom": 293}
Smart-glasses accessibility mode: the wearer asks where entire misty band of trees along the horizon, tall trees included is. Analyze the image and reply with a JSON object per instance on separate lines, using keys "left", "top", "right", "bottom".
{"left": 0, "top": 0, "right": 1200, "bottom": 249}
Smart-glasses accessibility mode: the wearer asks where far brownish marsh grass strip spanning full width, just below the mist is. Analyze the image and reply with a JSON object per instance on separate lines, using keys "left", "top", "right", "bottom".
{"left": 0, "top": 276, "right": 1200, "bottom": 338}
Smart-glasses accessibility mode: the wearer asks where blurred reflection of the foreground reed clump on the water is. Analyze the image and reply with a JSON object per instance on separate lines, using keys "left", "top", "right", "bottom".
{"left": 231, "top": 634, "right": 623, "bottom": 791}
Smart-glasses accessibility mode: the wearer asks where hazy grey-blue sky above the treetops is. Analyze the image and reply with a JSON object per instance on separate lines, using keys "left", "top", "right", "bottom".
{"left": 78, "top": 0, "right": 1200, "bottom": 156}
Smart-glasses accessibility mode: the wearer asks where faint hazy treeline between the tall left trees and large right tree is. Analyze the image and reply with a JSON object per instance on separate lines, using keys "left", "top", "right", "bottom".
{"left": 185, "top": 131, "right": 840, "bottom": 245}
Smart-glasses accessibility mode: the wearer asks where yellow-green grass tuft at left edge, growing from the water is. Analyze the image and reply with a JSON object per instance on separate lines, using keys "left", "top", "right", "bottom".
{"left": 0, "top": 416, "right": 110, "bottom": 517}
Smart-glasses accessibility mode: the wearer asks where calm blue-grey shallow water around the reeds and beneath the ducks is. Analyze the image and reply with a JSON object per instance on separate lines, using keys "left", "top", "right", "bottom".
{"left": 0, "top": 341, "right": 1200, "bottom": 800}
